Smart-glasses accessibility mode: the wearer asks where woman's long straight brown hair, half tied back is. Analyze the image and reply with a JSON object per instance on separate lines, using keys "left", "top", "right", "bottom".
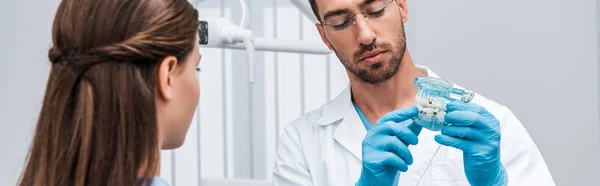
{"left": 19, "top": 0, "right": 198, "bottom": 186}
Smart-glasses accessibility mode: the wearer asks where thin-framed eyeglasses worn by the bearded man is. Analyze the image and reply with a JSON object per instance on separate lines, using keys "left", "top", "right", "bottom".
{"left": 322, "top": 0, "right": 394, "bottom": 32}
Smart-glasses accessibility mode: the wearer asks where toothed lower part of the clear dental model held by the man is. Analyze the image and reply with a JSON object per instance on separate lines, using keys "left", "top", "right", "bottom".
{"left": 416, "top": 94, "right": 447, "bottom": 125}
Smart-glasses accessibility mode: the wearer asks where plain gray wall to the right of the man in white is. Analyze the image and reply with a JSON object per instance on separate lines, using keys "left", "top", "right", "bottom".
{"left": 409, "top": 0, "right": 600, "bottom": 185}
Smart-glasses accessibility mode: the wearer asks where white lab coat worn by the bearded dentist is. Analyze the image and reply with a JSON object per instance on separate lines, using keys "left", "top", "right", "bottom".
{"left": 273, "top": 66, "right": 555, "bottom": 186}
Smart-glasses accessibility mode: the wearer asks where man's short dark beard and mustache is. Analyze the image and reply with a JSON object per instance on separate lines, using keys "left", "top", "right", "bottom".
{"left": 334, "top": 26, "right": 406, "bottom": 85}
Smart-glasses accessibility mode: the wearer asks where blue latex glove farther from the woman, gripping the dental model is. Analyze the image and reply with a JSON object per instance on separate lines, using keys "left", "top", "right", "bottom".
{"left": 435, "top": 102, "right": 508, "bottom": 186}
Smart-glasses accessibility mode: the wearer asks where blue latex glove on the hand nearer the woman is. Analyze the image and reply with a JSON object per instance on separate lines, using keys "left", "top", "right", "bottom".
{"left": 356, "top": 106, "right": 422, "bottom": 186}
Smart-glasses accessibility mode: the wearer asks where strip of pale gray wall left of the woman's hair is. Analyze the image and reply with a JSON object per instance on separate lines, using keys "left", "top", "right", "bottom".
{"left": 0, "top": 0, "right": 59, "bottom": 185}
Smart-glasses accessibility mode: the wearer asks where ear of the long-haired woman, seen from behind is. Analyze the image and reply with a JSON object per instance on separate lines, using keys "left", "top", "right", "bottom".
{"left": 156, "top": 56, "right": 177, "bottom": 100}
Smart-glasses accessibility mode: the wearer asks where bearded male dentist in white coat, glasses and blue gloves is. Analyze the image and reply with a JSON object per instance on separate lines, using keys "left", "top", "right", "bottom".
{"left": 273, "top": 0, "right": 554, "bottom": 186}
